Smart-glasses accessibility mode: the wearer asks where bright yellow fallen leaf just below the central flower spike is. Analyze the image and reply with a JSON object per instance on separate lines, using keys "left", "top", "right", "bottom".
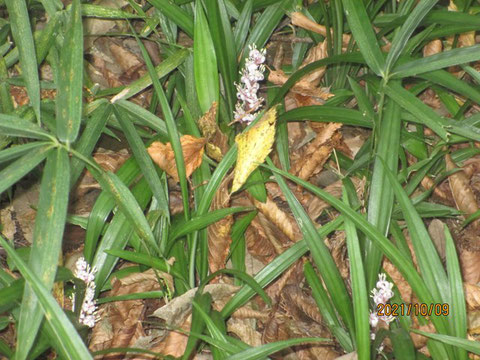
{"left": 232, "top": 107, "right": 277, "bottom": 192}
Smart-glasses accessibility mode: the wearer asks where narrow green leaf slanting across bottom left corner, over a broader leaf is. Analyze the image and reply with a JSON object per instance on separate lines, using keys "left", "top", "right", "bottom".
{"left": 0, "top": 236, "right": 93, "bottom": 360}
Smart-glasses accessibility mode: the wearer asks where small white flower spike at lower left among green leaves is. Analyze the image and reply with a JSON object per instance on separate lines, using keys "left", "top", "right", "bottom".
{"left": 74, "top": 257, "right": 98, "bottom": 328}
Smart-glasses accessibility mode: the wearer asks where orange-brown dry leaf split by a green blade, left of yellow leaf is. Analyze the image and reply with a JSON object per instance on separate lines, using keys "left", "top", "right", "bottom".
{"left": 147, "top": 135, "right": 205, "bottom": 182}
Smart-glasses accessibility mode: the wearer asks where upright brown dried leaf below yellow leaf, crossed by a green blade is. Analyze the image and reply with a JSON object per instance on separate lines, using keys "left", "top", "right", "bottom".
{"left": 207, "top": 175, "right": 233, "bottom": 273}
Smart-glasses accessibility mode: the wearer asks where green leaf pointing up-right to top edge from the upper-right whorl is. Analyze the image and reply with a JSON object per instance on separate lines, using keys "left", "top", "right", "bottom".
{"left": 385, "top": 0, "right": 438, "bottom": 76}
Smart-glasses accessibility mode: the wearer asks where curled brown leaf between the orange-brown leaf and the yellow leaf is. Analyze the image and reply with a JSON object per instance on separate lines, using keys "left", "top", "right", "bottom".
{"left": 198, "top": 101, "right": 228, "bottom": 161}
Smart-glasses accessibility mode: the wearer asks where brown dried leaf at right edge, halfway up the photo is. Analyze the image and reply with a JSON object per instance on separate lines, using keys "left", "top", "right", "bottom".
{"left": 445, "top": 154, "right": 478, "bottom": 214}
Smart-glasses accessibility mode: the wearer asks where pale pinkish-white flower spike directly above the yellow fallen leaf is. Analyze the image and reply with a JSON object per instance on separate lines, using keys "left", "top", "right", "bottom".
{"left": 234, "top": 45, "right": 266, "bottom": 123}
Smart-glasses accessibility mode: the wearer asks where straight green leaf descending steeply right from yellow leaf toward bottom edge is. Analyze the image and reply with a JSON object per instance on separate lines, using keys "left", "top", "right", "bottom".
{"left": 267, "top": 158, "right": 355, "bottom": 337}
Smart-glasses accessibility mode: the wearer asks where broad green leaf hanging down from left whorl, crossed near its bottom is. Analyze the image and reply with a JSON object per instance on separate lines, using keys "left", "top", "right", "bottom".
{"left": 16, "top": 148, "right": 70, "bottom": 360}
